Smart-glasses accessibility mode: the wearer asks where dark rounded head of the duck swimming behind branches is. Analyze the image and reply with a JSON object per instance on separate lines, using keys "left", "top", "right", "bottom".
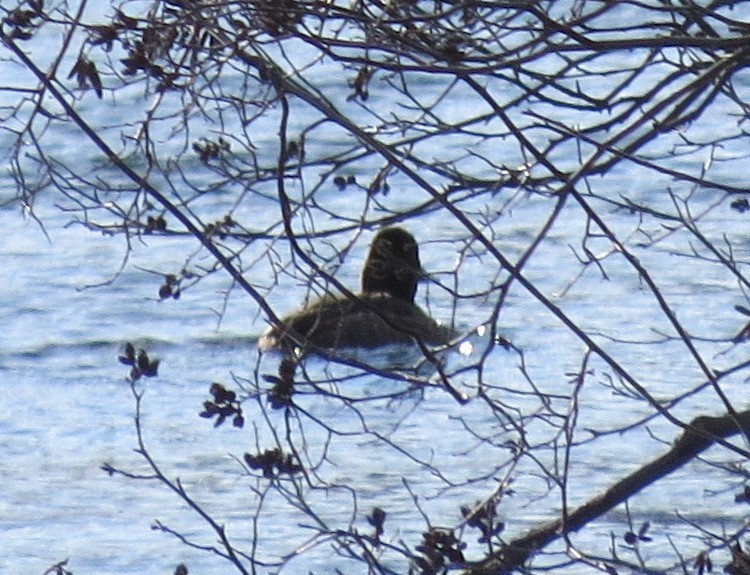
{"left": 362, "top": 228, "right": 424, "bottom": 303}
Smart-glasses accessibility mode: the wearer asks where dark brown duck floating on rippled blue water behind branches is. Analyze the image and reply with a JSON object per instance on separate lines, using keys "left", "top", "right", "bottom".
{"left": 258, "top": 227, "right": 454, "bottom": 351}
